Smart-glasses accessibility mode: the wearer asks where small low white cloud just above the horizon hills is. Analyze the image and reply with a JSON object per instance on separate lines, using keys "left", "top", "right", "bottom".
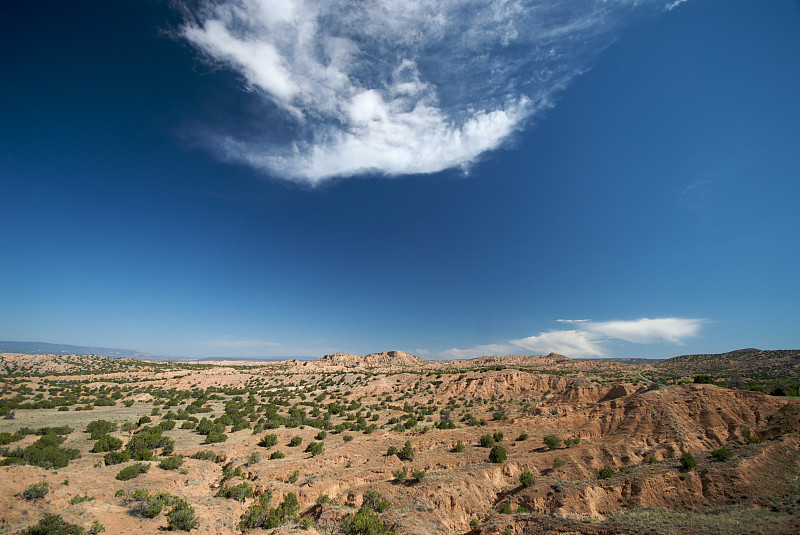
{"left": 442, "top": 318, "right": 705, "bottom": 359}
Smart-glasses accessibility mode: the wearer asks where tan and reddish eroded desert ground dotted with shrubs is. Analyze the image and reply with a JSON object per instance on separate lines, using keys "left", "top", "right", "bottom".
{"left": 0, "top": 351, "right": 800, "bottom": 534}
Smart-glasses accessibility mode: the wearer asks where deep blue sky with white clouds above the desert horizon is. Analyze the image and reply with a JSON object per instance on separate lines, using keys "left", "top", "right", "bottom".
{"left": 0, "top": 0, "right": 800, "bottom": 358}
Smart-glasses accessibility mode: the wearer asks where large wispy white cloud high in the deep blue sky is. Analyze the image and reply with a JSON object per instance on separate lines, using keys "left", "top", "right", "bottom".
{"left": 180, "top": 0, "right": 658, "bottom": 184}
